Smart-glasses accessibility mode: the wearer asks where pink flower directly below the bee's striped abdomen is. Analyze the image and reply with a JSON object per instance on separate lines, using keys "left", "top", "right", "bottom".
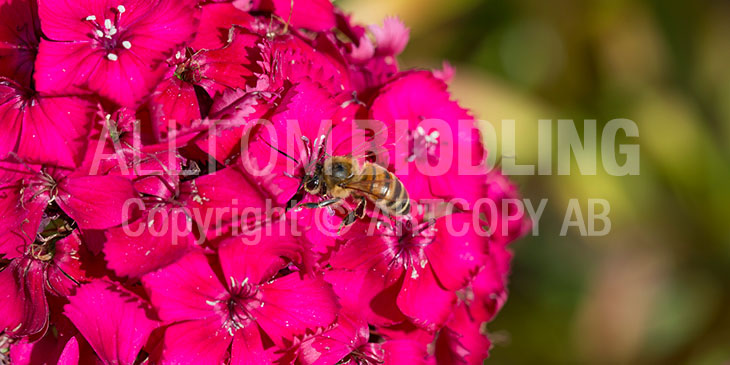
{"left": 326, "top": 210, "right": 486, "bottom": 331}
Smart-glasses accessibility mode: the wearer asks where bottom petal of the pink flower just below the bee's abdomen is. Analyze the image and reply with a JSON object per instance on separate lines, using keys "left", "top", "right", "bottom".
{"left": 397, "top": 265, "right": 456, "bottom": 331}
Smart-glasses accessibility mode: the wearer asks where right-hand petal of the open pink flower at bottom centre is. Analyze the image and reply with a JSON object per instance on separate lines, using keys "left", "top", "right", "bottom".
{"left": 255, "top": 273, "right": 338, "bottom": 344}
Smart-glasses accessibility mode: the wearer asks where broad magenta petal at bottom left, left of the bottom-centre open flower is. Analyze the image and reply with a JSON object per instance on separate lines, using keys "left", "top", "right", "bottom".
{"left": 64, "top": 281, "right": 157, "bottom": 364}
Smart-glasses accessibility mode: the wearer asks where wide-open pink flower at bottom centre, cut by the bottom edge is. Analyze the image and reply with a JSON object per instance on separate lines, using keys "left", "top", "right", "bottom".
{"left": 143, "top": 243, "right": 337, "bottom": 363}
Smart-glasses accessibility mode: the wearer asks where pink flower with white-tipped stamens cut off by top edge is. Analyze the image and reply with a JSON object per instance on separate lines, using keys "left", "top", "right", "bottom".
{"left": 35, "top": 0, "right": 197, "bottom": 107}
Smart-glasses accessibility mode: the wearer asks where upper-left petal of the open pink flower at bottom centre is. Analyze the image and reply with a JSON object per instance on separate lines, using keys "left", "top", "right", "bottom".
{"left": 142, "top": 252, "right": 226, "bottom": 322}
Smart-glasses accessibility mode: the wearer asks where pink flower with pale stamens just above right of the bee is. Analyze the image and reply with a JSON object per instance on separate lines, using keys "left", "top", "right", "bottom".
{"left": 370, "top": 71, "right": 487, "bottom": 202}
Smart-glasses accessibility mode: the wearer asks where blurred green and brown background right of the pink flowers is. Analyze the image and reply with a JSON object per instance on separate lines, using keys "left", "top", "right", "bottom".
{"left": 336, "top": 0, "right": 730, "bottom": 364}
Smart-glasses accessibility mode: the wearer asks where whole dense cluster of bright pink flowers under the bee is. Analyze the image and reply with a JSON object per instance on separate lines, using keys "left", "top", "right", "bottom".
{"left": 0, "top": 0, "right": 529, "bottom": 364}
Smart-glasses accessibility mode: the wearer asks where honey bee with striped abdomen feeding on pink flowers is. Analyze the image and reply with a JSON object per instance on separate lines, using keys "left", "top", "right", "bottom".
{"left": 292, "top": 156, "right": 411, "bottom": 227}
